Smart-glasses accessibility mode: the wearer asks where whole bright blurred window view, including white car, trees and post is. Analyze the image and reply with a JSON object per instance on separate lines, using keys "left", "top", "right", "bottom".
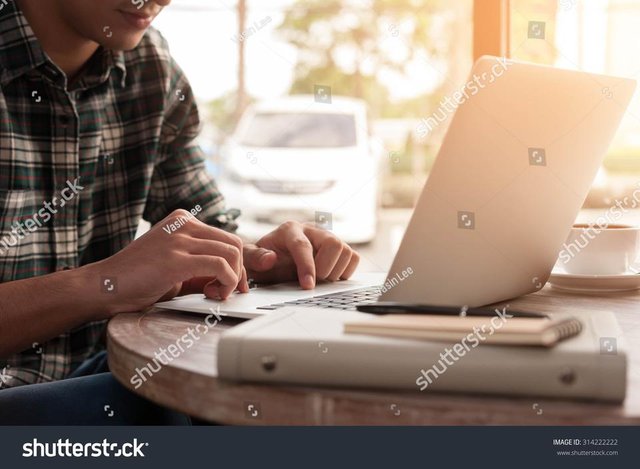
{"left": 155, "top": 0, "right": 640, "bottom": 270}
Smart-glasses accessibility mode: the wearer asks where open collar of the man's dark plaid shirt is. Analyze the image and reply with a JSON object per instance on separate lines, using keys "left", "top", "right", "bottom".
{"left": 0, "top": 0, "right": 127, "bottom": 87}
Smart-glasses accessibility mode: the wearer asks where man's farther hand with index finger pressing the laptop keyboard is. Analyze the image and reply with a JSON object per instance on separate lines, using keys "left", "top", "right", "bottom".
{"left": 244, "top": 221, "right": 360, "bottom": 290}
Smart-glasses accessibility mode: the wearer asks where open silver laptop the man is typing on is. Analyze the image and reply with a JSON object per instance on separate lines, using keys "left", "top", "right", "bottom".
{"left": 156, "top": 56, "right": 635, "bottom": 318}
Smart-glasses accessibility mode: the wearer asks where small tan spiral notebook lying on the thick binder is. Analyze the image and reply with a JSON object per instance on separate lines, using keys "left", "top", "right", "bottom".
{"left": 344, "top": 314, "right": 582, "bottom": 347}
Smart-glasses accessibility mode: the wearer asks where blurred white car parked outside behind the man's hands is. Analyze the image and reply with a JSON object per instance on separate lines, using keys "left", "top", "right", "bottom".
{"left": 220, "top": 95, "right": 383, "bottom": 243}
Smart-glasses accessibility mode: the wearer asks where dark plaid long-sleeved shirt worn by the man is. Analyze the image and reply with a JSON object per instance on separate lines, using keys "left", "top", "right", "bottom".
{"left": 0, "top": 2, "right": 235, "bottom": 388}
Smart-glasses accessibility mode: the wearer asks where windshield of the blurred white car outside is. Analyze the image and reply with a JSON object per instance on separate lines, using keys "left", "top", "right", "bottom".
{"left": 240, "top": 112, "right": 356, "bottom": 148}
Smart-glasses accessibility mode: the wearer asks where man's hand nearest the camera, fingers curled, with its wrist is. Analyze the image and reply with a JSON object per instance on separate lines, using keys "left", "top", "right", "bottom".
{"left": 84, "top": 210, "right": 249, "bottom": 314}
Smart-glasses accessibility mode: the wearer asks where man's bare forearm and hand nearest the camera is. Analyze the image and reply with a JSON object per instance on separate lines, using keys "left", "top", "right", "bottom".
{"left": 0, "top": 210, "right": 248, "bottom": 357}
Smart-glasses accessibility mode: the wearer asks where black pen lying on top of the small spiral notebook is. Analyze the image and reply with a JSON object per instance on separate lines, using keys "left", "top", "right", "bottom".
{"left": 356, "top": 301, "right": 549, "bottom": 319}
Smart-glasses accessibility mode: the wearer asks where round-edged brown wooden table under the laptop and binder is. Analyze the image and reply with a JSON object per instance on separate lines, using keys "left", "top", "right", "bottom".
{"left": 108, "top": 285, "right": 640, "bottom": 425}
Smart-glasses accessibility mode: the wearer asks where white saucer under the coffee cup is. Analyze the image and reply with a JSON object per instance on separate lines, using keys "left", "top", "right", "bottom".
{"left": 549, "top": 268, "right": 640, "bottom": 293}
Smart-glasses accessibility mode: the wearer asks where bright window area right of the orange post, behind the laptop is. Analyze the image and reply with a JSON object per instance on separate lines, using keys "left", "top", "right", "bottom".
{"left": 510, "top": 0, "right": 640, "bottom": 205}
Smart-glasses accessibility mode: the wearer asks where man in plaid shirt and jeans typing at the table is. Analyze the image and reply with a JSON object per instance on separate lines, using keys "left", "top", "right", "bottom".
{"left": 0, "top": 0, "right": 358, "bottom": 424}
